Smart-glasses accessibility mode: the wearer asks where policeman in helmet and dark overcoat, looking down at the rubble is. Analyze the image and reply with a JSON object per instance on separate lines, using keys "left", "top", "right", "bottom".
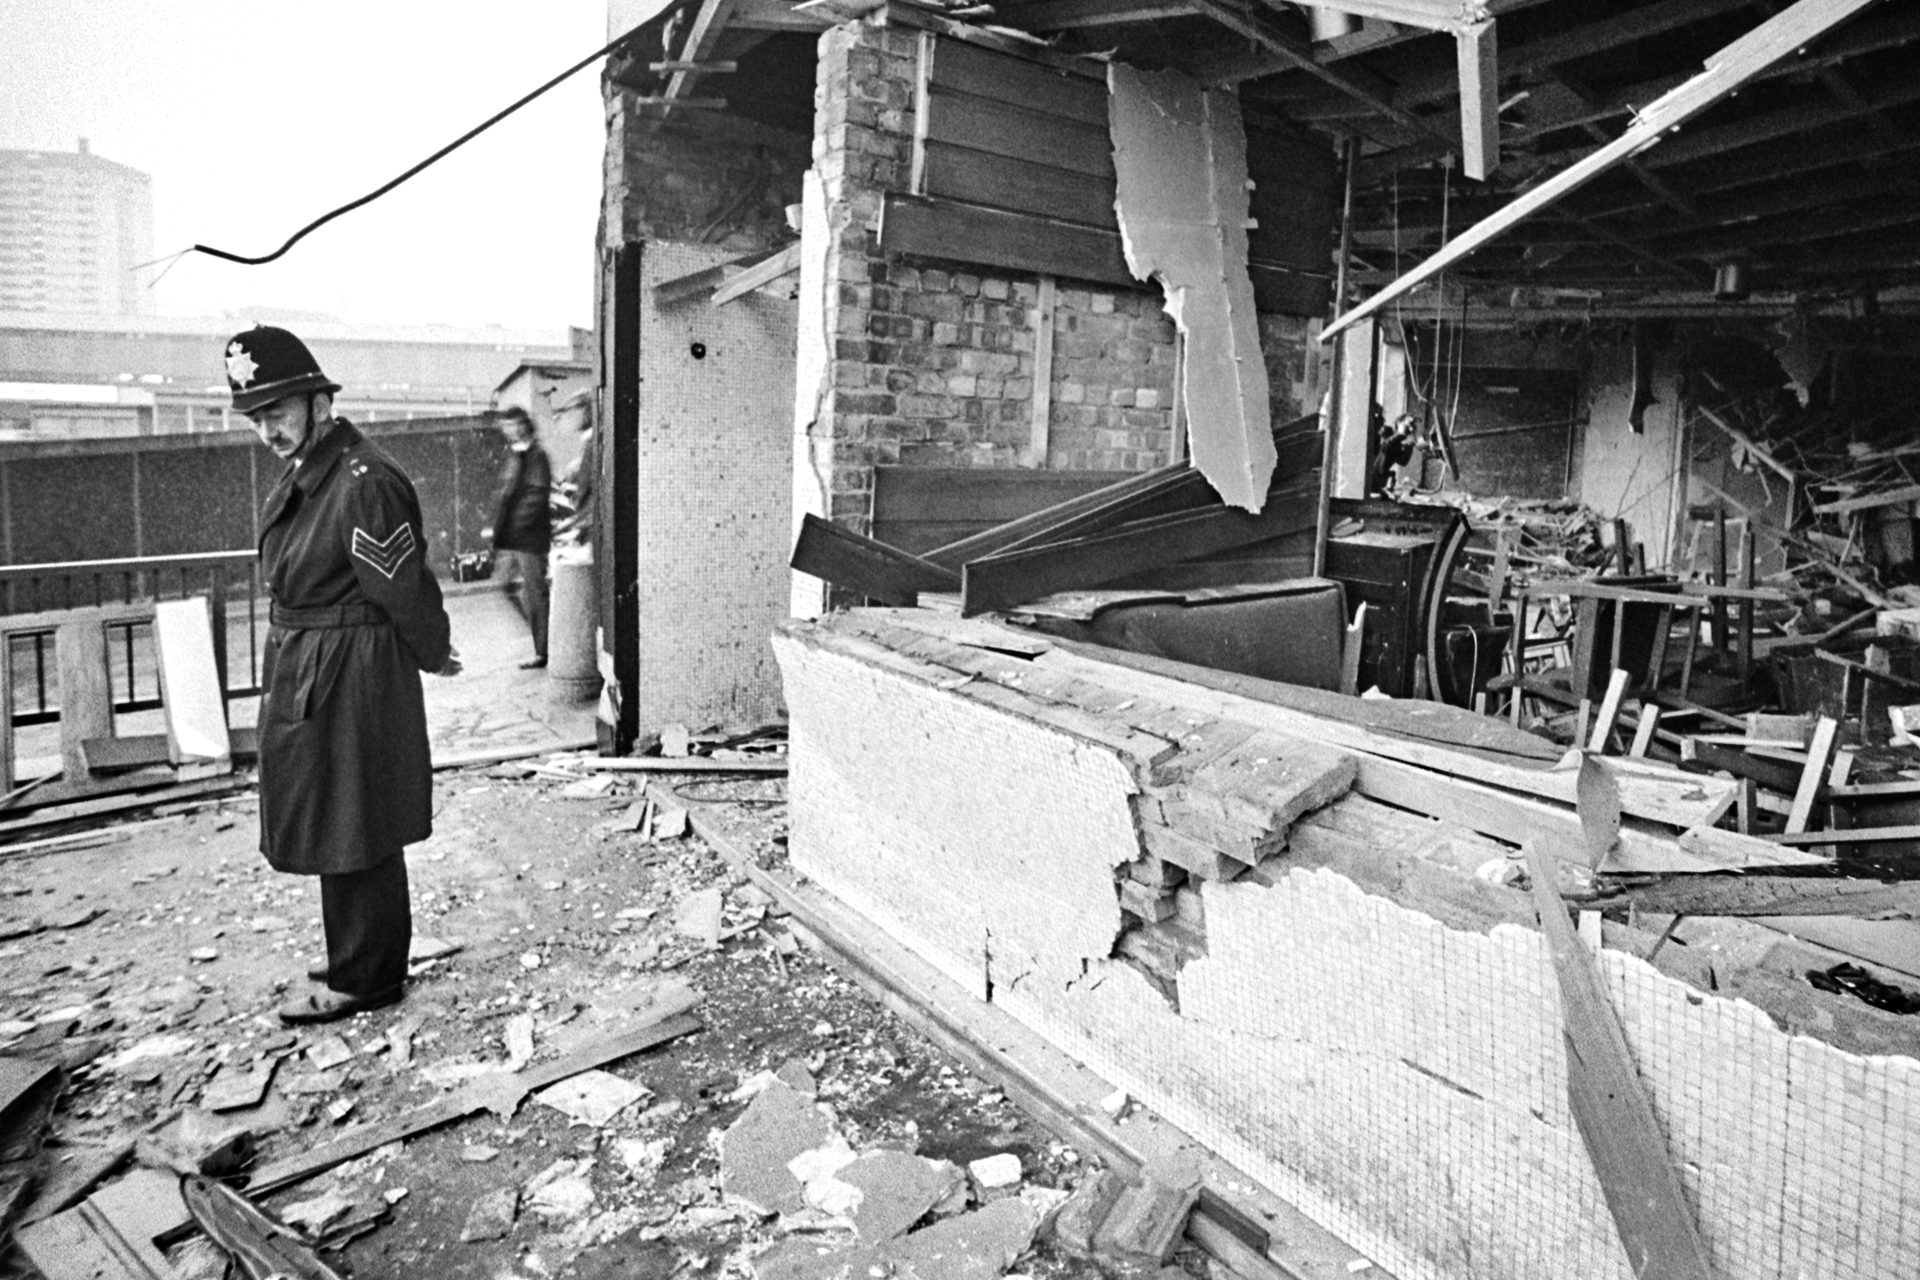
{"left": 227, "top": 326, "right": 461, "bottom": 1023}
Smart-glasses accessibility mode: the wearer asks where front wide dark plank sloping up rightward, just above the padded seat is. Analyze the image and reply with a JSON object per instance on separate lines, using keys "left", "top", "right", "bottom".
{"left": 960, "top": 486, "right": 1319, "bottom": 616}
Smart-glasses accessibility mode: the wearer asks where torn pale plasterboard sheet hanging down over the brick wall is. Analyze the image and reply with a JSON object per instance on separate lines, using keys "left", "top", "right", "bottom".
{"left": 1106, "top": 61, "right": 1275, "bottom": 512}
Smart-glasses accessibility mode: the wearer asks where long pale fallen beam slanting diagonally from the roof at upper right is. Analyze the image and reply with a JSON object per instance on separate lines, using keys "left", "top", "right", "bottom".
{"left": 1321, "top": 0, "right": 1874, "bottom": 342}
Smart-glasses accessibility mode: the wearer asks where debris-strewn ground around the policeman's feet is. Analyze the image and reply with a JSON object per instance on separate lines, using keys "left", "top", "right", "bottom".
{"left": 0, "top": 752, "right": 1198, "bottom": 1280}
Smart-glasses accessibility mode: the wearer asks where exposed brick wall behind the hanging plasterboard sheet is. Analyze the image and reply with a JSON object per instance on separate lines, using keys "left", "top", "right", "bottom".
{"left": 808, "top": 23, "right": 1321, "bottom": 532}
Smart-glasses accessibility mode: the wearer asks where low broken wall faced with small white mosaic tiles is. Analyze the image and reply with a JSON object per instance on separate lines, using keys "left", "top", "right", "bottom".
{"left": 774, "top": 610, "right": 1920, "bottom": 1280}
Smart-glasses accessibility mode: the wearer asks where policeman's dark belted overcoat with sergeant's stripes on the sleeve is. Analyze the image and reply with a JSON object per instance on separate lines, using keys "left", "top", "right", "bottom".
{"left": 259, "top": 418, "right": 449, "bottom": 875}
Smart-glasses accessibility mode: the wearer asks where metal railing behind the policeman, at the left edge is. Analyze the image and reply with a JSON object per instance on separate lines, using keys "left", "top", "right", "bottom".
{"left": 0, "top": 551, "right": 265, "bottom": 727}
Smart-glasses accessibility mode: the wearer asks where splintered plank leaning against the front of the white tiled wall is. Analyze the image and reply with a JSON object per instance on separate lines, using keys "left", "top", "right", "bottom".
{"left": 1526, "top": 842, "right": 1713, "bottom": 1280}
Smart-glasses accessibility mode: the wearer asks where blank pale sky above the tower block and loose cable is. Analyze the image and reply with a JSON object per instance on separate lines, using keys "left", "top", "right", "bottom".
{"left": 0, "top": 0, "right": 607, "bottom": 328}
